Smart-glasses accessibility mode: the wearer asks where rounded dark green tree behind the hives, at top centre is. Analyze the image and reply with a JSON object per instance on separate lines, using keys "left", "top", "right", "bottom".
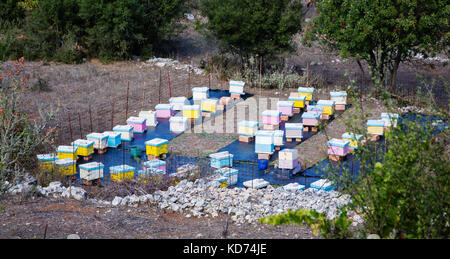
{"left": 200, "top": 0, "right": 303, "bottom": 64}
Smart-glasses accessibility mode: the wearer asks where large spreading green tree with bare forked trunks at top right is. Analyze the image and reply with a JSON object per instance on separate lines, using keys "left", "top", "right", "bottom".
{"left": 305, "top": 0, "right": 450, "bottom": 89}
